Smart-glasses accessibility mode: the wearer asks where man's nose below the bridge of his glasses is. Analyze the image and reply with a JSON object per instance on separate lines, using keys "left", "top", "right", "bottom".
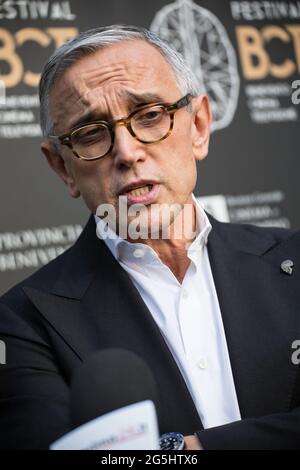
{"left": 112, "top": 124, "right": 146, "bottom": 167}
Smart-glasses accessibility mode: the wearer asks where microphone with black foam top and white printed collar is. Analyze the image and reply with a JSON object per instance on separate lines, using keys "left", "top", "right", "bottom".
{"left": 50, "top": 349, "right": 159, "bottom": 450}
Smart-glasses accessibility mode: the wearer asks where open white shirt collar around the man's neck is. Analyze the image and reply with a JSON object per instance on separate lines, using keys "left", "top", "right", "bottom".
{"left": 94, "top": 194, "right": 212, "bottom": 263}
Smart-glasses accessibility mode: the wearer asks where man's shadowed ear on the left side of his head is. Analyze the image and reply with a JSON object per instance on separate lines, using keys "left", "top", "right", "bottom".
{"left": 41, "top": 142, "right": 80, "bottom": 198}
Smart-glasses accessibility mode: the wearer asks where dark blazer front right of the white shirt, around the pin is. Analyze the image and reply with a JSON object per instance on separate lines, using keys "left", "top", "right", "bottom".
{"left": 208, "top": 218, "right": 300, "bottom": 418}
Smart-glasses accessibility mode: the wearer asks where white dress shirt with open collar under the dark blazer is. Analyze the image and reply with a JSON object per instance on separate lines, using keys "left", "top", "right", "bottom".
{"left": 95, "top": 196, "right": 241, "bottom": 428}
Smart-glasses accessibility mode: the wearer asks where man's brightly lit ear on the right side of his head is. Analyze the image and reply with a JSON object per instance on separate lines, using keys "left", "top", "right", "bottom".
{"left": 192, "top": 95, "right": 212, "bottom": 160}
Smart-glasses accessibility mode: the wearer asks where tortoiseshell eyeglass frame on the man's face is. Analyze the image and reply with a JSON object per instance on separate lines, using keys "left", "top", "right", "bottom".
{"left": 48, "top": 93, "right": 194, "bottom": 161}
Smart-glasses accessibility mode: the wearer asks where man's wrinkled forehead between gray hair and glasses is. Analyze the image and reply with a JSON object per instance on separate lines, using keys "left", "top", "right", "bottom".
{"left": 50, "top": 41, "right": 179, "bottom": 130}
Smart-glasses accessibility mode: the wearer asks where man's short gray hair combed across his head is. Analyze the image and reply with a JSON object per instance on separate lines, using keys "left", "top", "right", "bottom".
{"left": 39, "top": 25, "right": 202, "bottom": 136}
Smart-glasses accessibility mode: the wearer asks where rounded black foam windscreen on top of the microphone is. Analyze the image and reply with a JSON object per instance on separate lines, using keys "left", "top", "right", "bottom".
{"left": 70, "top": 349, "right": 157, "bottom": 428}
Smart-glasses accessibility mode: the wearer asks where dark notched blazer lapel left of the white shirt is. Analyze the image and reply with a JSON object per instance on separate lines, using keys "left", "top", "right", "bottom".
{"left": 25, "top": 218, "right": 203, "bottom": 433}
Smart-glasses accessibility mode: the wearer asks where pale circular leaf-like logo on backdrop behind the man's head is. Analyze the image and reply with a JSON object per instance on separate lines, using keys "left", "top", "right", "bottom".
{"left": 150, "top": 0, "right": 240, "bottom": 130}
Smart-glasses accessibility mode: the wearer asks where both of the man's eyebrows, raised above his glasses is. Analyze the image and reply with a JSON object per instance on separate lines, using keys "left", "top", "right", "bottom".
{"left": 70, "top": 91, "right": 164, "bottom": 129}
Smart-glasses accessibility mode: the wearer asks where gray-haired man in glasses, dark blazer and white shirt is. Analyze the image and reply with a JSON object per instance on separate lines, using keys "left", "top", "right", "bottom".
{"left": 0, "top": 26, "right": 300, "bottom": 450}
